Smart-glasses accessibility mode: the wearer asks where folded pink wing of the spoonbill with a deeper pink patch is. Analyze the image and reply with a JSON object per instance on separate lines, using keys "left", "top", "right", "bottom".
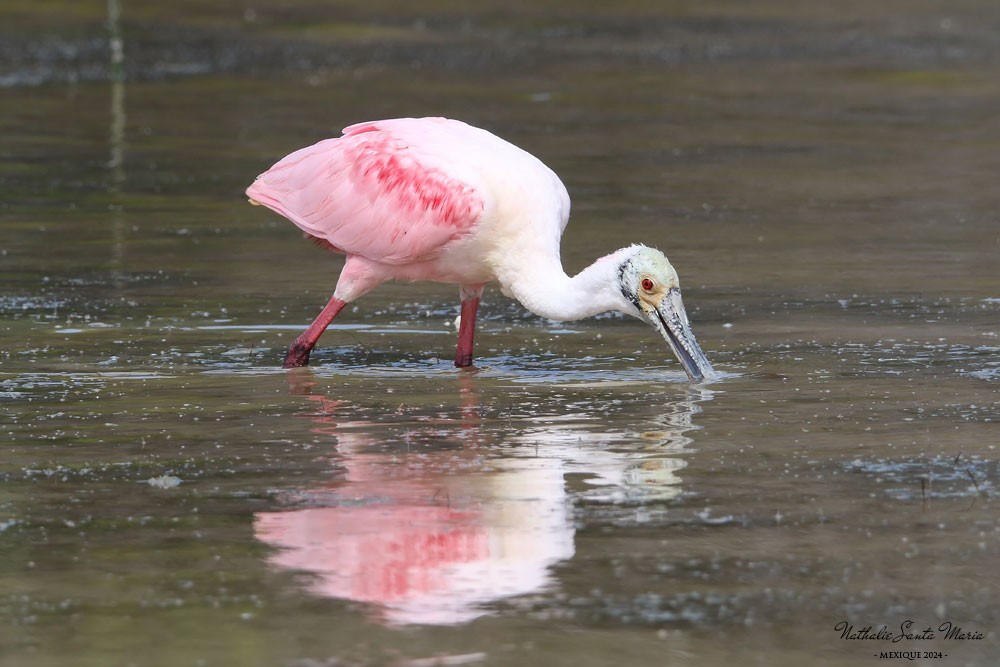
{"left": 247, "top": 119, "right": 485, "bottom": 264}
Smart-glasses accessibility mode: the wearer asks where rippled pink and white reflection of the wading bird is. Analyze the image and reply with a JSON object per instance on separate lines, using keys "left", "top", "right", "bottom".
{"left": 254, "top": 369, "right": 711, "bottom": 624}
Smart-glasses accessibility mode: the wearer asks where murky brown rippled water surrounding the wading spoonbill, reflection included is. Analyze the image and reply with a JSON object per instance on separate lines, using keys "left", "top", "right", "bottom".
{"left": 0, "top": 1, "right": 1000, "bottom": 667}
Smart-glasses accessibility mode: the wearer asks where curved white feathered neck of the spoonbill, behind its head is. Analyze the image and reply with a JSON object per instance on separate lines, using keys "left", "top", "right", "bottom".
{"left": 500, "top": 253, "right": 625, "bottom": 321}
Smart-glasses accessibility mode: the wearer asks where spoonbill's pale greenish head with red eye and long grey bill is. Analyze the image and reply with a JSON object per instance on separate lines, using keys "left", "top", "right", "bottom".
{"left": 618, "top": 245, "right": 715, "bottom": 382}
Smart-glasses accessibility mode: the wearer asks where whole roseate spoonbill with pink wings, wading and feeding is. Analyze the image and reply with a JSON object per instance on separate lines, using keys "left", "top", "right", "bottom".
{"left": 246, "top": 118, "right": 714, "bottom": 382}
